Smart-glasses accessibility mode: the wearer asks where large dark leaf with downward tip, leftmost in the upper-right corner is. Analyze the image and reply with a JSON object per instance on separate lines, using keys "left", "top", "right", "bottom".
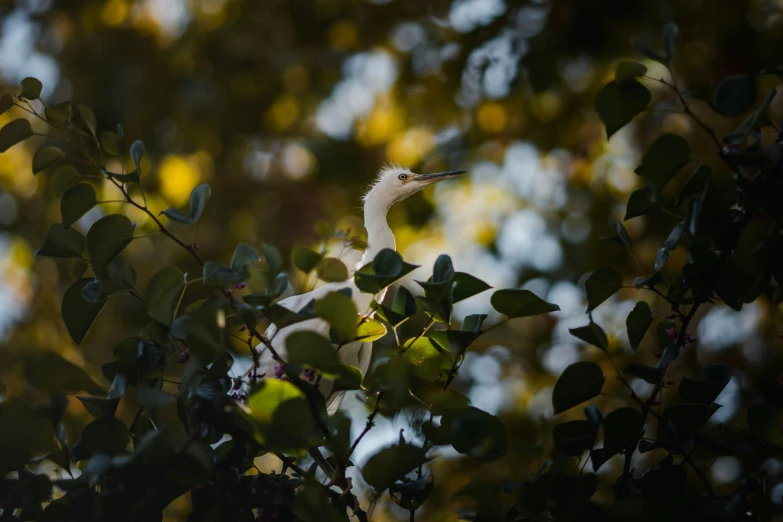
{"left": 595, "top": 80, "right": 651, "bottom": 139}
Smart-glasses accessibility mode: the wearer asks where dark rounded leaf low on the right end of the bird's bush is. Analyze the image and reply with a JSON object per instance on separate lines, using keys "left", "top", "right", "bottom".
{"left": 440, "top": 406, "right": 508, "bottom": 462}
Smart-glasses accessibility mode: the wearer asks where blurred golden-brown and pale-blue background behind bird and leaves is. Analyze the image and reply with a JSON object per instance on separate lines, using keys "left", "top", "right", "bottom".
{"left": 0, "top": 0, "right": 783, "bottom": 520}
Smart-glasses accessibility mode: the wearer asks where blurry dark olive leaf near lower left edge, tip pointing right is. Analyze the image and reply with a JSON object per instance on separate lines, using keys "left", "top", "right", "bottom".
{"left": 24, "top": 352, "right": 106, "bottom": 395}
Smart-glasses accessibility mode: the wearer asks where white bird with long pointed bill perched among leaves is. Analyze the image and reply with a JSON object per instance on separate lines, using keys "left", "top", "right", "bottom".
{"left": 256, "top": 165, "right": 464, "bottom": 415}
